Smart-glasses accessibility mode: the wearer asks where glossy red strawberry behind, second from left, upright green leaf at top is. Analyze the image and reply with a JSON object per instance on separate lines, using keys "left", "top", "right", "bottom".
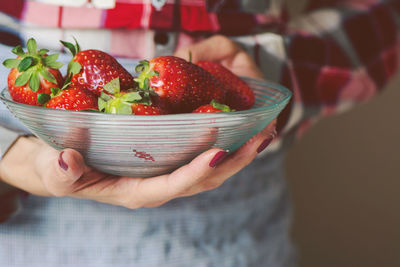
{"left": 60, "top": 40, "right": 135, "bottom": 96}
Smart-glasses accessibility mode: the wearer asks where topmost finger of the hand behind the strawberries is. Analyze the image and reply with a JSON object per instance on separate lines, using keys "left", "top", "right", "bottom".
{"left": 174, "top": 35, "right": 241, "bottom": 62}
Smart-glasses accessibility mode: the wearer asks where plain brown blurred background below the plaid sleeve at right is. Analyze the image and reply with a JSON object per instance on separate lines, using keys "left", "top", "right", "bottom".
{"left": 286, "top": 65, "right": 400, "bottom": 267}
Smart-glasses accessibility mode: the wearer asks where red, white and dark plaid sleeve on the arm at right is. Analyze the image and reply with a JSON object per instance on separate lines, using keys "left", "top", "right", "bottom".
{"left": 255, "top": 0, "right": 400, "bottom": 141}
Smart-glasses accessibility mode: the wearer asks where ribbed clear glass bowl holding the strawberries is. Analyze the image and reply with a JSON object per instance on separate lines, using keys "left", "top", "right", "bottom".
{"left": 0, "top": 78, "right": 291, "bottom": 177}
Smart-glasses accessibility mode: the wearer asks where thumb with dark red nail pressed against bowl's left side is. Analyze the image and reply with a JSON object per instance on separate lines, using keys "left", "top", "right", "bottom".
{"left": 38, "top": 149, "right": 85, "bottom": 196}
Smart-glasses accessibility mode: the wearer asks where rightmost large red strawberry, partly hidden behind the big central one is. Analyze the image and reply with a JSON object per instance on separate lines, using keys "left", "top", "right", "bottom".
{"left": 196, "top": 61, "right": 255, "bottom": 110}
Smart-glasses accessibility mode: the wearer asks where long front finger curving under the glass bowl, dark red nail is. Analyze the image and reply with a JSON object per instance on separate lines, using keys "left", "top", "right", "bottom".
{"left": 73, "top": 149, "right": 227, "bottom": 209}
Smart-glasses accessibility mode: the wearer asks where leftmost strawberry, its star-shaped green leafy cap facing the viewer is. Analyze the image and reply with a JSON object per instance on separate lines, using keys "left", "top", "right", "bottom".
{"left": 3, "top": 38, "right": 63, "bottom": 106}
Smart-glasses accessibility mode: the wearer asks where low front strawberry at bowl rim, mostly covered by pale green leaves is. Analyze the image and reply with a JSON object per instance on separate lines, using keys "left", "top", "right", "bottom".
{"left": 98, "top": 78, "right": 167, "bottom": 115}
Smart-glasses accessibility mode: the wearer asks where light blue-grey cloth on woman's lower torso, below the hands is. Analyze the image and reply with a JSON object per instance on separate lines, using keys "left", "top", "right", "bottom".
{"left": 0, "top": 152, "right": 294, "bottom": 267}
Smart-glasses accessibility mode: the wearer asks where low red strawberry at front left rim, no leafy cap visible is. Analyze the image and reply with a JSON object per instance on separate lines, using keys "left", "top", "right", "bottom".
{"left": 45, "top": 87, "right": 97, "bottom": 111}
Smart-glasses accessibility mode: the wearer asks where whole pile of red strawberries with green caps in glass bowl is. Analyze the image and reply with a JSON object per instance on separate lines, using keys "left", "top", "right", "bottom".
{"left": 3, "top": 38, "right": 254, "bottom": 115}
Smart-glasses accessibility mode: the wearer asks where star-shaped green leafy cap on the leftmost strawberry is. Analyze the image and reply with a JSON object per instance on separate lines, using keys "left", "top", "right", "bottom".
{"left": 3, "top": 38, "right": 64, "bottom": 92}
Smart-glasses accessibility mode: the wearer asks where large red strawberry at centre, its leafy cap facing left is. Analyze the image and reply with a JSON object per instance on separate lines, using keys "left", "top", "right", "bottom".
{"left": 135, "top": 56, "right": 225, "bottom": 113}
